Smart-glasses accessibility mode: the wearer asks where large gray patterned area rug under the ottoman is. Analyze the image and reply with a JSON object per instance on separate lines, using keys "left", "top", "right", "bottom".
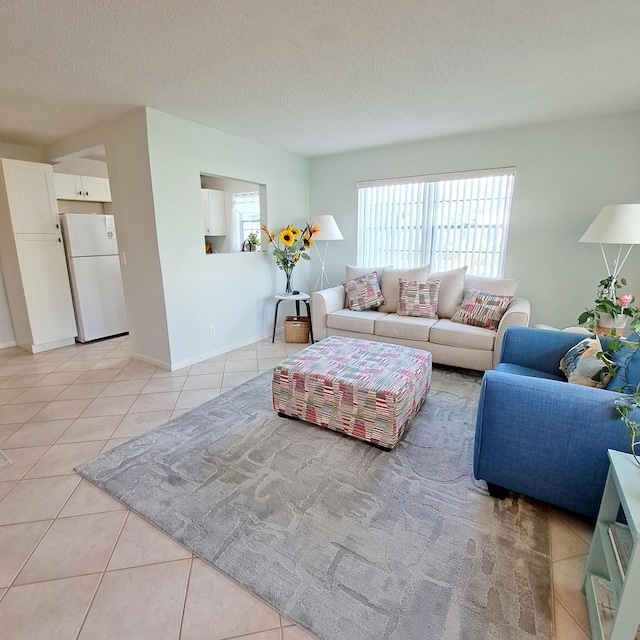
{"left": 77, "top": 367, "right": 552, "bottom": 640}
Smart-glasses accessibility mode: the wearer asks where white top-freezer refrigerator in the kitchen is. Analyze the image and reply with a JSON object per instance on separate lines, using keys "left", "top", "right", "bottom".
{"left": 60, "top": 213, "right": 128, "bottom": 342}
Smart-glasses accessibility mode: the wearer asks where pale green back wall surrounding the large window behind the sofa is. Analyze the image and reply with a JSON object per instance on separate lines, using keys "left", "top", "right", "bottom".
{"left": 310, "top": 112, "right": 640, "bottom": 327}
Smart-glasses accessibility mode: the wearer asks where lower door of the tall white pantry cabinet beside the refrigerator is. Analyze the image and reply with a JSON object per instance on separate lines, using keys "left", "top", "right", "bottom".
{"left": 15, "top": 233, "right": 77, "bottom": 345}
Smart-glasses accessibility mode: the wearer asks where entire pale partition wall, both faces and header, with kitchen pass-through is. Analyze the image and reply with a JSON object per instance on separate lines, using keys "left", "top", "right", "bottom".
{"left": 46, "top": 109, "right": 309, "bottom": 369}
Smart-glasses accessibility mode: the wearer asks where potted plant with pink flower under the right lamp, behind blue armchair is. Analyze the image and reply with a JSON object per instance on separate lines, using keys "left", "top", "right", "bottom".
{"left": 578, "top": 276, "right": 640, "bottom": 337}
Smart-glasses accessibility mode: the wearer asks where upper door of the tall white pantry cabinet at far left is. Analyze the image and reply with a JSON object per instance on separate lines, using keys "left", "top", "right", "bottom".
{"left": 2, "top": 160, "right": 59, "bottom": 233}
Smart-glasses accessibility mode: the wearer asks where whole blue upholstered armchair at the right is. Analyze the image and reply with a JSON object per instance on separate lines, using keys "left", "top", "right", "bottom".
{"left": 474, "top": 326, "right": 640, "bottom": 517}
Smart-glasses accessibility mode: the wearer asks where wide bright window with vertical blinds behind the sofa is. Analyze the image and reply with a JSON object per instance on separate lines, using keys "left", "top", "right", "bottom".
{"left": 358, "top": 168, "right": 515, "bottom": 277}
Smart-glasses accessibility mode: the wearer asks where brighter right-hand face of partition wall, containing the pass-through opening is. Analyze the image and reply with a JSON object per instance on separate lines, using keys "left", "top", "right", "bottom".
{"left": 147, "top": 110, "right": 309, "bottom": 368}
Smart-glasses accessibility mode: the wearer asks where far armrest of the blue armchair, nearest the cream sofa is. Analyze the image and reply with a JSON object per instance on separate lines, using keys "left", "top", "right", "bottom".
{"left": 500, "top": 326, "right": 585, "bottom": 375}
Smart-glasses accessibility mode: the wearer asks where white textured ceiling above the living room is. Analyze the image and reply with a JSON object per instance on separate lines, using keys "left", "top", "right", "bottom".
{"left": 0, "top": 0, "right": 640, "bottom": 156}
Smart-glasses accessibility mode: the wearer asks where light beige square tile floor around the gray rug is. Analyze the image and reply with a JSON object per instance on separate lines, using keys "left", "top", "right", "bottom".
{"left": 0, "top": 337, "right": 592, "bottom": 640}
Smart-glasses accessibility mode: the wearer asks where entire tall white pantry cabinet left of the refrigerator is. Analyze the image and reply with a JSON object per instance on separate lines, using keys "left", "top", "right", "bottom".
{"left": 0, "top": 160, "right": 77, "bottom": 353}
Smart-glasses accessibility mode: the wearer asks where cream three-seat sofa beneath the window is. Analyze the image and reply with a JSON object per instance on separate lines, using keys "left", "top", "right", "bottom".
{"left": 311, "top": 266, "right": 530, "bottom": 371}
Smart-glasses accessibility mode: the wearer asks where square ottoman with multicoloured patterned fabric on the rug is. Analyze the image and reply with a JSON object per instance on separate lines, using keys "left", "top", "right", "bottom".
{"left": 272, "top": 336, "right": 431, "bottom": 450}
